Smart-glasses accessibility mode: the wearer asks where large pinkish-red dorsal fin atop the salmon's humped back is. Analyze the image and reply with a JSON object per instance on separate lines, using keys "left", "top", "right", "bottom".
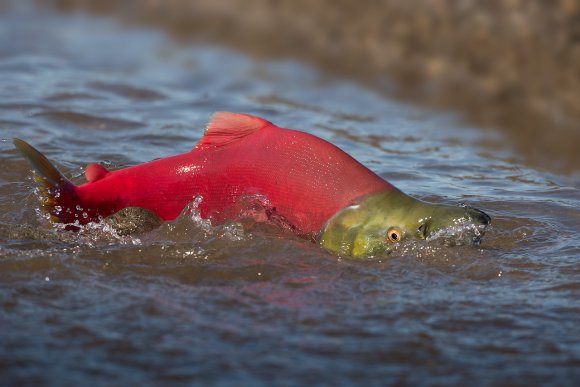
{"left": 195, "top": 112, "right": 272, "bottom": 149}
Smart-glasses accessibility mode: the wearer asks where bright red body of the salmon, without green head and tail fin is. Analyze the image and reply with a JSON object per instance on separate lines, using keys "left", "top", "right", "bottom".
{"left": 60, "top": 113, "right": 392, "bottom": 235}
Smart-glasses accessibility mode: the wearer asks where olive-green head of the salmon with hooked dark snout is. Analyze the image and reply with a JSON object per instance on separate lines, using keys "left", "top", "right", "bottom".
{"left": 320, "top": 188, "right": 491, "bottom": 257}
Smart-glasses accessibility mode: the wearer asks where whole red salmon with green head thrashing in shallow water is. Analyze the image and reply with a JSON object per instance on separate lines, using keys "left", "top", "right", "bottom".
{"left": 13, "top": 112, "right": 491, "bottom": 257}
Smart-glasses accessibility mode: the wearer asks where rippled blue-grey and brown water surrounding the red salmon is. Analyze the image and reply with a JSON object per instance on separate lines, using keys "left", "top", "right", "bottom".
{"left": 0, "top": 7, "right": 580, "bottom": 385}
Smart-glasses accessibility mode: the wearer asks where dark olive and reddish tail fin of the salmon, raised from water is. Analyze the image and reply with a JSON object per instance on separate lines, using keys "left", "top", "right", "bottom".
{"left": 12, "top": 138, "right": 77, "bottom": 223}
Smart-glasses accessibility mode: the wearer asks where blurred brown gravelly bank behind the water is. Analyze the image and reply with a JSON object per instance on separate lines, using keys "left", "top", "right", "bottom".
{"left": 48, "top": 0, "right": 580, "bottom": 173}
